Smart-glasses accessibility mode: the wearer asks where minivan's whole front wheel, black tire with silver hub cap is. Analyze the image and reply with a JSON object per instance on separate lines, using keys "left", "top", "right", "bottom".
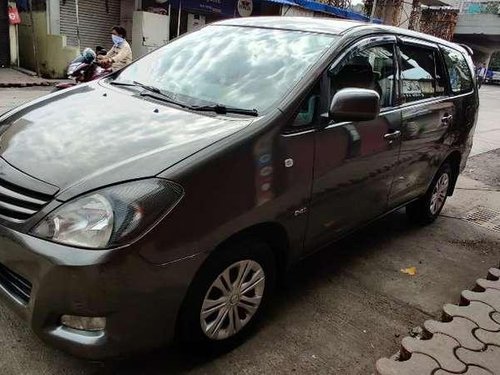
{"left": 177, "top": 241, "right": 276, "bottom": 351}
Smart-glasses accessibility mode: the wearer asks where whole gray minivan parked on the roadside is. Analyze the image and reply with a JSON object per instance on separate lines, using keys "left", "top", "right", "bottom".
{"left": 0, "top": 17, "right": 478, "bottom": 359}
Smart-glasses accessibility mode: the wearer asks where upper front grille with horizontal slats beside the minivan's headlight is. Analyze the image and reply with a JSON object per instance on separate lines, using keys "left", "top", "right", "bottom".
{"left": 0, "top": 179, "right": 53, "bottom": 222}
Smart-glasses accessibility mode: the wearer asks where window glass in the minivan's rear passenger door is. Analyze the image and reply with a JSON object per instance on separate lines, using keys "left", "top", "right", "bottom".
{"left": 400, "top": 45, "right": 445, "bottom": 103}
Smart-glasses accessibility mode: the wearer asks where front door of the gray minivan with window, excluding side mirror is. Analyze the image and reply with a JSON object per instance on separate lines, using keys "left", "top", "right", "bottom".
{"left": 306, "top": 37, "right": 401, "bottom": 249}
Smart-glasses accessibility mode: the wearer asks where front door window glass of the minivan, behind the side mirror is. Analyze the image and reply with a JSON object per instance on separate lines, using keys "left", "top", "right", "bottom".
{"left": 329, "top": 44, "right": 395, "bottom": 108}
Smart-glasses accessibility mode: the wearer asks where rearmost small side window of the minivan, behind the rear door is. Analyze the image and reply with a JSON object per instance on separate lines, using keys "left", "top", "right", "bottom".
{"left": 441, "top": 47, "right": 473, "bottom": 94}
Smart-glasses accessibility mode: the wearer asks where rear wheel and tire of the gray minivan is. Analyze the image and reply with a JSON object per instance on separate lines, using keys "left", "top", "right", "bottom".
{"left": 406, "top": 163, "right": 453, "bottom": 225}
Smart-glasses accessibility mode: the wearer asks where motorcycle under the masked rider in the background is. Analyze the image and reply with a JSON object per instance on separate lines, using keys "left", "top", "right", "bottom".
{"left": 54, "top": 47, "right": 111, "bottom": 91}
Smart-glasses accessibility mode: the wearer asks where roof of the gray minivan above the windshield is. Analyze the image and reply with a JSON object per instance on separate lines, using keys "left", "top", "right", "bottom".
{"left": 216, "top": 16, "right": 468, "bottom": 53}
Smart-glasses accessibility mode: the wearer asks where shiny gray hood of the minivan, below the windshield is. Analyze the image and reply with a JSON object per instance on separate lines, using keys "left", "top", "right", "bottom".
{"left": 0, "top": 83, "right": 251, "bottom": 200}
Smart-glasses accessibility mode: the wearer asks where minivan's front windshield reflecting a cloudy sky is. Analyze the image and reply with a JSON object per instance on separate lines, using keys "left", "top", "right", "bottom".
{"left": 116, "top": 25, "right": 336, "bottom": 113}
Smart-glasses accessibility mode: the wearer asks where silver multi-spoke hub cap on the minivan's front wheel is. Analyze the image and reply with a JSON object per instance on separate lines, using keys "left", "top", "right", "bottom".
{"left": 200, "top": 260, "right": 266, "bottom": 340}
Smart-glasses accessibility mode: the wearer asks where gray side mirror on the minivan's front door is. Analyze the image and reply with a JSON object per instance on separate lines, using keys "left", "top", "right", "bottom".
{"left": 329, "top": 88, "right": 380, "bottom": 122}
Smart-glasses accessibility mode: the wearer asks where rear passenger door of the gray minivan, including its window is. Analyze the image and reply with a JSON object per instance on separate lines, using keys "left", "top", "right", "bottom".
{"left": 389, "top": 38, "right": 456, "bottom": 207}
